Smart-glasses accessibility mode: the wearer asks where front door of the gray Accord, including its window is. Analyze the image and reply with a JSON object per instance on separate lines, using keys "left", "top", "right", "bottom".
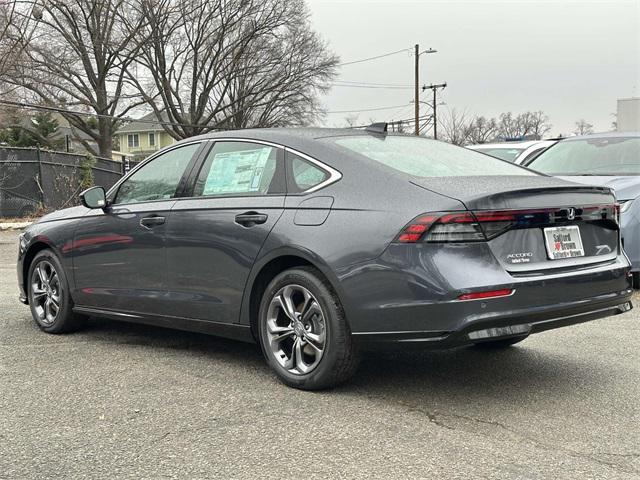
{"left": 72, "top": 142, "right": 202, "bottom": 314}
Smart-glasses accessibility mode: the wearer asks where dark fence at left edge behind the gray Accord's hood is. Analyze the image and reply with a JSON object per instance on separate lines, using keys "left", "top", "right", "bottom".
{"left": 0, "top": 147, "right": 126, "bottom": 217}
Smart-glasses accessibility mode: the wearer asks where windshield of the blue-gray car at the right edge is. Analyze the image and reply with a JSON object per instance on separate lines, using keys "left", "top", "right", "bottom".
{"left": 528, "top": 137, "right": 640, "bottom": 176}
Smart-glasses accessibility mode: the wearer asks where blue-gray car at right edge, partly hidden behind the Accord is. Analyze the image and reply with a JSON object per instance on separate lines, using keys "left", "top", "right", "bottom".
{"left": 528, "top": 132, "right": 640, "bottom": 287}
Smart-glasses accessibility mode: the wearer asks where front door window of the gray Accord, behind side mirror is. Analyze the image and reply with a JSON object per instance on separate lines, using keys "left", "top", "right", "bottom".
{"left": 114, "top": 143, "right": 200, "bottom": 204}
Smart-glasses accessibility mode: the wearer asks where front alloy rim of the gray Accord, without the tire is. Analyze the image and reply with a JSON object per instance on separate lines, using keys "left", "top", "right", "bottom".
{"left": 30, "top": 260, "right": 62, "bottom": 325}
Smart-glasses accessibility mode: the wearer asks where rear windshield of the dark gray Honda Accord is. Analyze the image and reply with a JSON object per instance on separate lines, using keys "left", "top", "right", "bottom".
{"left": 325, "top": 135, "right": 536, "bottom": 177}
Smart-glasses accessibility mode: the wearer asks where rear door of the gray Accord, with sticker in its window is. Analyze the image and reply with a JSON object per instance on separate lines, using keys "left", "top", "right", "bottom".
{"left": 167, "top": 140, "right": 286, "bottom": 323}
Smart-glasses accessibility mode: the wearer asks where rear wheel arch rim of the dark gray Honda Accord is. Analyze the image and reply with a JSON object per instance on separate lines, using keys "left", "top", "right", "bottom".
{"left": 240, "top": 248, "right": 348, "bottom": 342}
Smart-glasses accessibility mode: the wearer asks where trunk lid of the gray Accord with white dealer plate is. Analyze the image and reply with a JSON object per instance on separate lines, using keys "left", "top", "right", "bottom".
{"left": 412, "top": 176, "right": 619, "bottom": 274}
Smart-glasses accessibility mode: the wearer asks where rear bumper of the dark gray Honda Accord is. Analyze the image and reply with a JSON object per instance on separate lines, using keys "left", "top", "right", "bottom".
{"left": 347, "top": 246, "right": 633, "bottom": 347}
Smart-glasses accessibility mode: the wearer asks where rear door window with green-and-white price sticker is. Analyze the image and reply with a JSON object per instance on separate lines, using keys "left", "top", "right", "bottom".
{"left": 194, "top": 141, "right": 284, "bottom": 197}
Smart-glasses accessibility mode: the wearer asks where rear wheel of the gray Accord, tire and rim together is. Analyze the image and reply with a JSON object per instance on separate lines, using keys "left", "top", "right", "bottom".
{"left": 259, "top": 267, "right": 358, "bottom": 390}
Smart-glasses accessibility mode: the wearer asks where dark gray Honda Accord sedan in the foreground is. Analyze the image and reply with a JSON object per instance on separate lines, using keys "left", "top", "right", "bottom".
{"left": 18, "top": 125, "right": 631, "bottom": 389}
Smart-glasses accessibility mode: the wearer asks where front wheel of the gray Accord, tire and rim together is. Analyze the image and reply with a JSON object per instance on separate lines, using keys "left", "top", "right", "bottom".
{"left": 27, "top": 249, "right": 86, "bottom": 333}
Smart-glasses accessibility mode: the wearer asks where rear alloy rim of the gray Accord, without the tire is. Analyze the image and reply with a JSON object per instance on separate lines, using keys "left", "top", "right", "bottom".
{"left": 266, "top": 285, "right": 327, "bottom": 375}
